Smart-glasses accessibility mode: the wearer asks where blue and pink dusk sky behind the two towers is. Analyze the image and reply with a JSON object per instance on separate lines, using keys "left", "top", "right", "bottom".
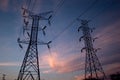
{"left": 0, "top": 0, "right": 120, "bottom": 80}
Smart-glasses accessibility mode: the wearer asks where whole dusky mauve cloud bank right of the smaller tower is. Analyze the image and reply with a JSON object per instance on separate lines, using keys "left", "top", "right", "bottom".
{"left": 96, "top": 21, "right": 120, "bottom": 63}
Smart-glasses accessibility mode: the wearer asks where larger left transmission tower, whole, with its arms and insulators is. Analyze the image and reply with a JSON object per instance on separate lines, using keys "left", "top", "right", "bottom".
{"left": 17, "top": 8, "right": 52, "bottom": 80}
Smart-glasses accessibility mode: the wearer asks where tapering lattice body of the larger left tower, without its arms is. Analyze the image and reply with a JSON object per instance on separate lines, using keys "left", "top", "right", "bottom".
{"left": 18, "top": 16, "right": 40, "bottom": 80}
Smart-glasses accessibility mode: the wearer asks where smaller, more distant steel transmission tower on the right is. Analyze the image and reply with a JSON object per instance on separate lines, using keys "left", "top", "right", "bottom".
{"left": 78, "top": 20, "right": 106, "bottom": 80}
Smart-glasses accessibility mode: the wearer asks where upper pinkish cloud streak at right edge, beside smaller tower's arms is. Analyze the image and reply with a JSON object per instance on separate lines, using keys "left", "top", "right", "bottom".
{"left": 96, "top": 21, "right": 120, "bottom": 48}
